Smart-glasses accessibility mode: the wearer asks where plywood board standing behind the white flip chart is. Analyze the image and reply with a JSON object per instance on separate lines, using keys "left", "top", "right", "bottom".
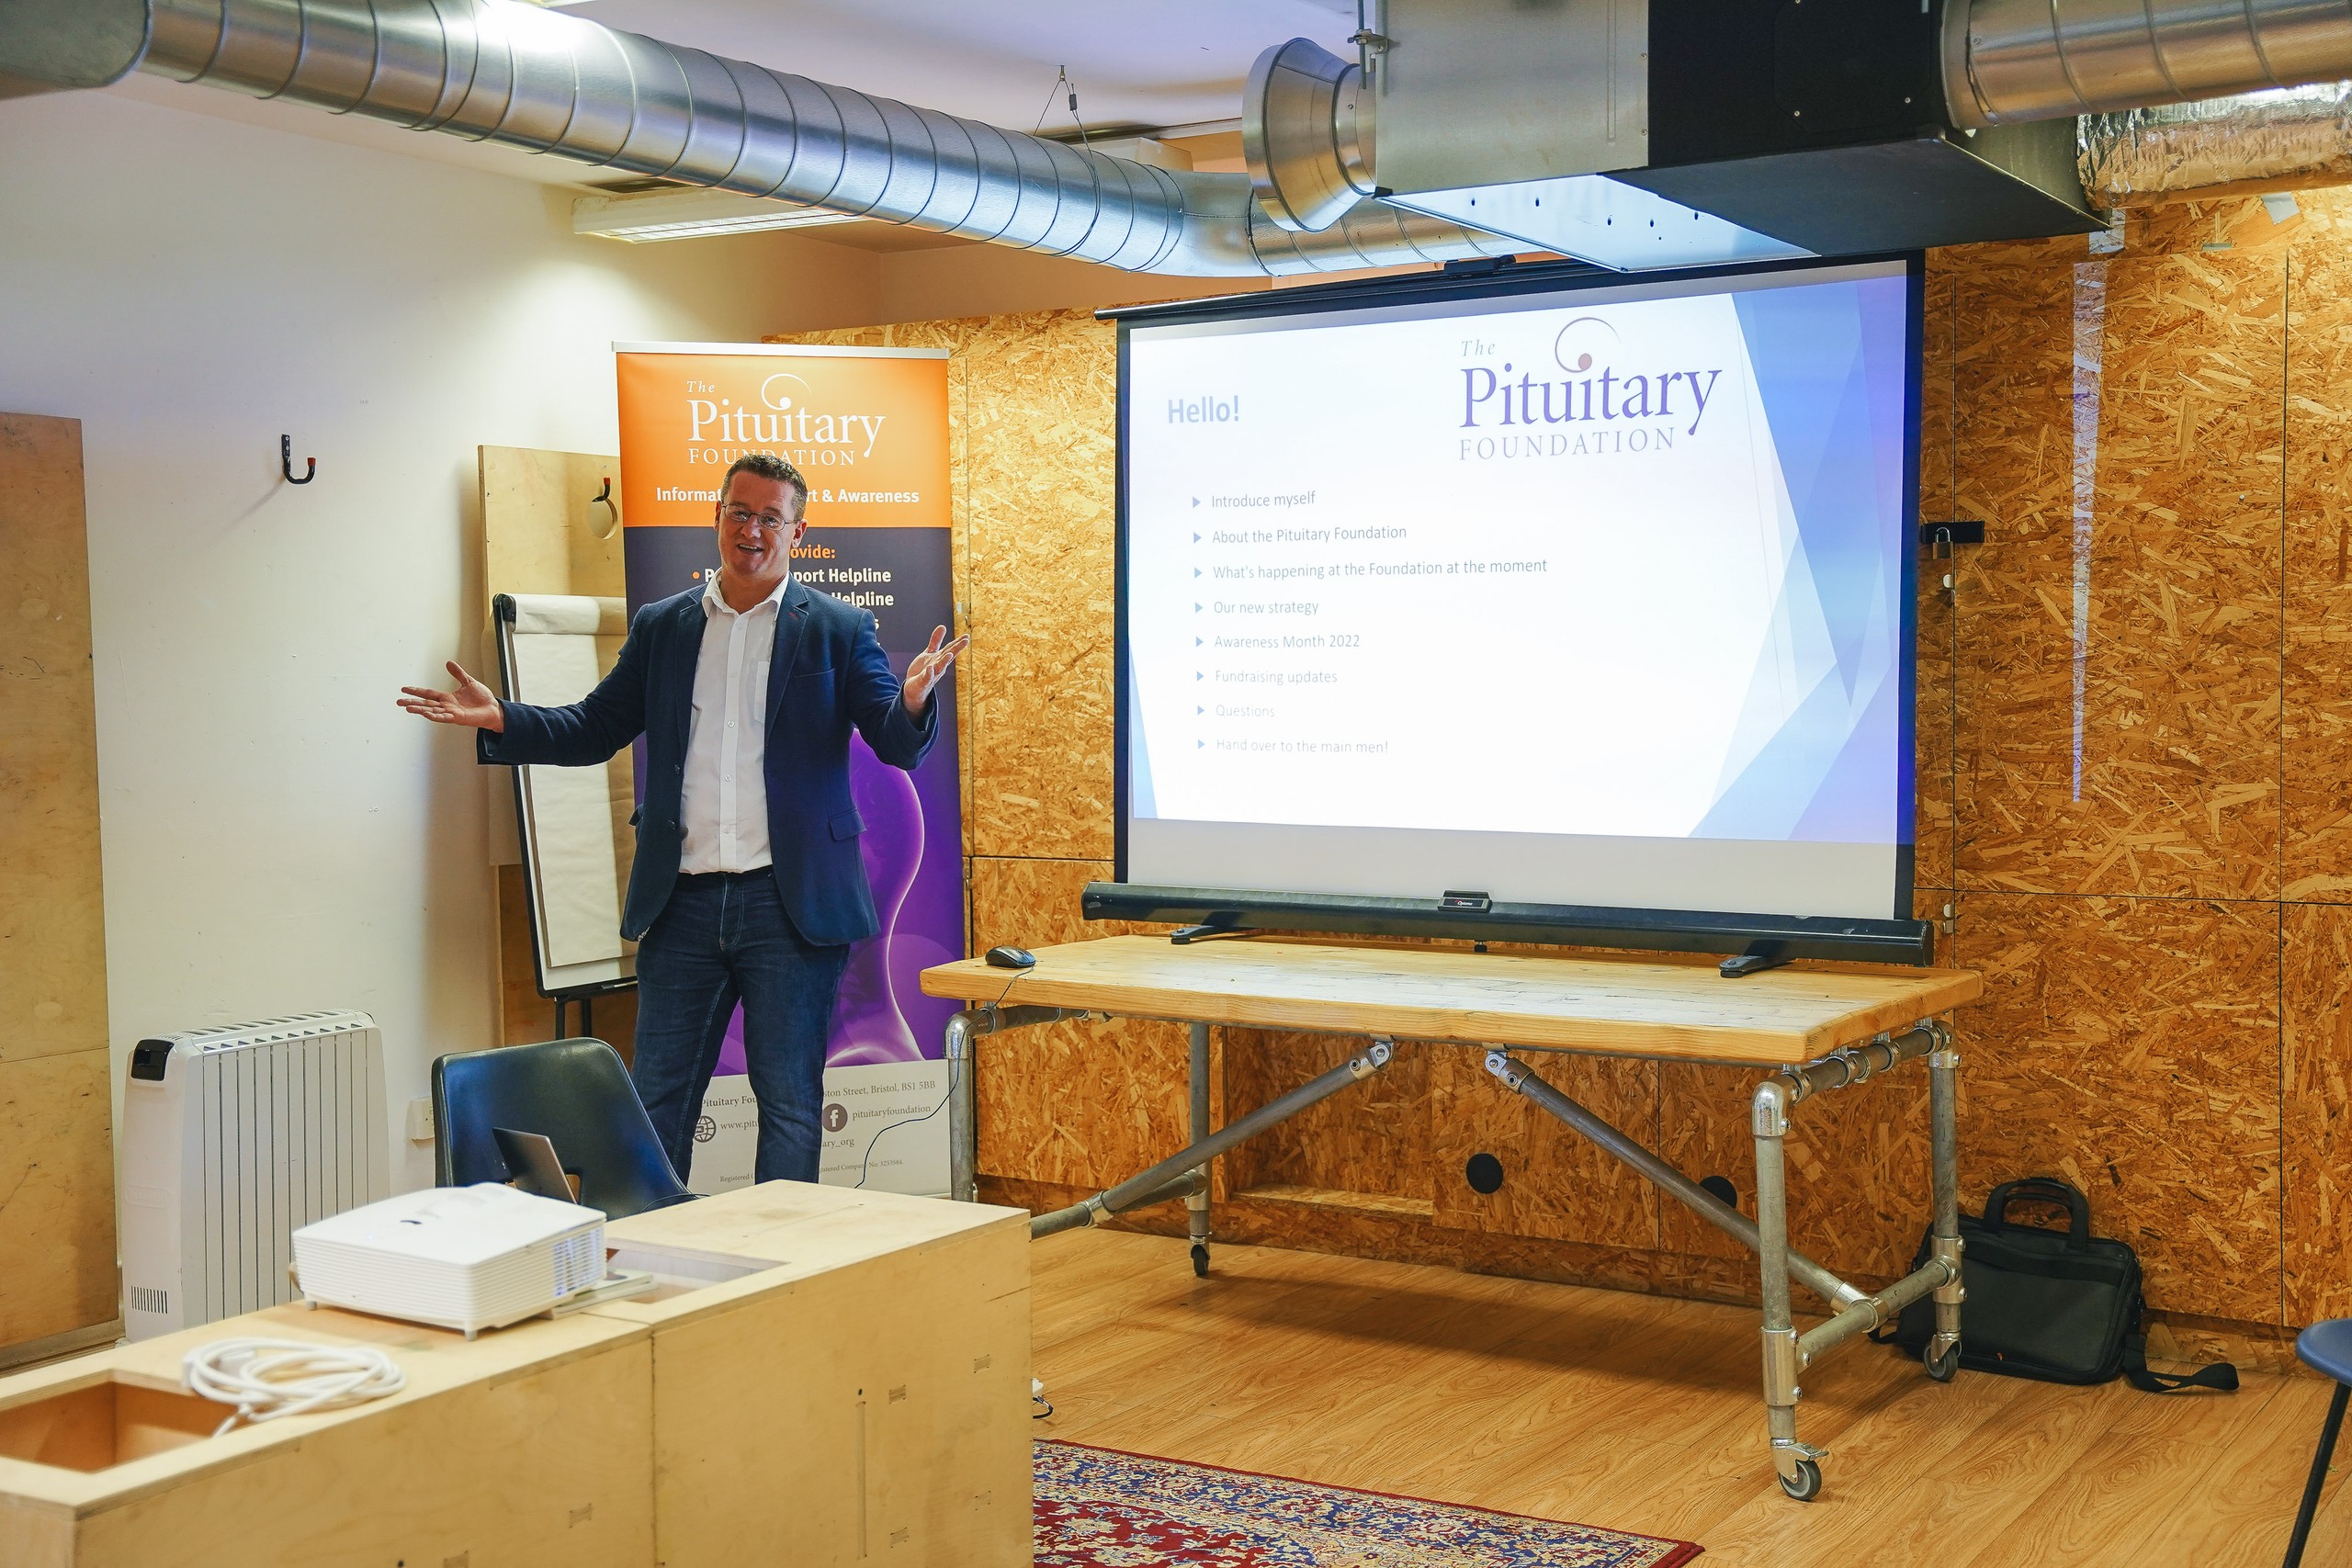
{"left": 470, "top": 446, "right": 638, "bottom": 1055}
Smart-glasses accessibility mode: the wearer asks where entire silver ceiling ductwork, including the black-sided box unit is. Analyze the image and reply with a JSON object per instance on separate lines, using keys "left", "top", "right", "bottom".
{"left": 18, "top": 0, "right": 2352, "bottom": 277}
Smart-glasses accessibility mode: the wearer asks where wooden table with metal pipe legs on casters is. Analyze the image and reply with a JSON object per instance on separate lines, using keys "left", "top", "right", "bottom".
{"left": 922, "top": 936, "right": 1983, "bottom": 1500}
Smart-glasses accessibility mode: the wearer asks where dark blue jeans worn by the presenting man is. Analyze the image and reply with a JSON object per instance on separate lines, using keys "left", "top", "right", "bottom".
{"left": 628, "top": 870, "right": 849, "bottom": 1182}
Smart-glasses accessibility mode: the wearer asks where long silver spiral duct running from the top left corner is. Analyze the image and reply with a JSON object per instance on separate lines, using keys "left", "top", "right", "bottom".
{"left": 0, "top": 0, "right": 1524, "bottom": 277}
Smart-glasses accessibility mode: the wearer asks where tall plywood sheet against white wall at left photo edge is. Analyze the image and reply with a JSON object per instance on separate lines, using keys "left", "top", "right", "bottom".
{"left": 0, "top": 413, "right": 118, "bottom": 1363}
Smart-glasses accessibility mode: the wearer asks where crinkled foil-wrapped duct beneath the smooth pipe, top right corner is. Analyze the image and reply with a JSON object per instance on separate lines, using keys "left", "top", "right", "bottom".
{"left": 2079, "top": 83, "right": 2352, "bottom": 207}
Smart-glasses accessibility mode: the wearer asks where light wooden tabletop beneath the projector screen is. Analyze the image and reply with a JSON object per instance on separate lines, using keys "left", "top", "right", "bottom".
{"left": 922, "top": 936, "right": 1985, "bottom": 1067}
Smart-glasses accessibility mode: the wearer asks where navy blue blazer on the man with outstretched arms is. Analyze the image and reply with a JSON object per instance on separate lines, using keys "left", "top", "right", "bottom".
{"left": 475, "top": 576, "right": 938, "bottom": 945}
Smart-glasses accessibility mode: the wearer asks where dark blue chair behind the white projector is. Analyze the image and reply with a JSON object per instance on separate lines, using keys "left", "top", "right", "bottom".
{"left": 433, "top": 1039, "right": 694, "bottom": 1220}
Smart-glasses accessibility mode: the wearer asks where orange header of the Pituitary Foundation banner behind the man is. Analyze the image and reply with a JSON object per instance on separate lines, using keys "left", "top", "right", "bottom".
{"left": 614, "top": 344, "right": 948, "bottom": 529}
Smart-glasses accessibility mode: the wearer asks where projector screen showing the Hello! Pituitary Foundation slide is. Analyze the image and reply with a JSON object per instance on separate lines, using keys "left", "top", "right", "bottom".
{"left": 1120, "top": 261, "right": 1917, "bottom": 921}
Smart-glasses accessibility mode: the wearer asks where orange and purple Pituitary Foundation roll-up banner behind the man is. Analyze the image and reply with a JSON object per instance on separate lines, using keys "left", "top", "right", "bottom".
{"left": 614, "top": 344, "right": 965, "bottom": 1194}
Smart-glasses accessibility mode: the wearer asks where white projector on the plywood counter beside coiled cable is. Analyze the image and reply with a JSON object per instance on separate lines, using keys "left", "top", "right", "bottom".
{"left": 294, "top": 1182, "right": 605, "bottom": 1340}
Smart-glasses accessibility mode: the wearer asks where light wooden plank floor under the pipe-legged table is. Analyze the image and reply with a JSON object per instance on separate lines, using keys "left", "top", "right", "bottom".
{"left": 1035, "top": 1229, "right": 2352, "bottom": 1568}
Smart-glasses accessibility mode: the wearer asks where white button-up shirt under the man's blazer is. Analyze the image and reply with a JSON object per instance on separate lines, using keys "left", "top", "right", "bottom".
{"left": 677, "top": 571, "right": 793, "bottom": 874}
